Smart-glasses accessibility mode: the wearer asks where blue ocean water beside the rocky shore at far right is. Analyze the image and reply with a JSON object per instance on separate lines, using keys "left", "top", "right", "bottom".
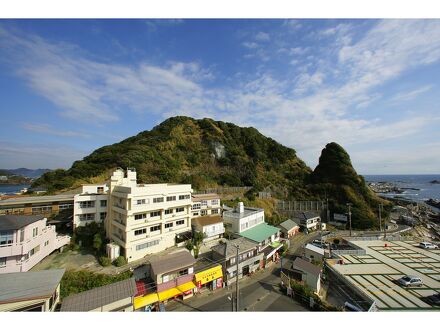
{"left": 364, "top": 174, "right": 440, "bottom": 202}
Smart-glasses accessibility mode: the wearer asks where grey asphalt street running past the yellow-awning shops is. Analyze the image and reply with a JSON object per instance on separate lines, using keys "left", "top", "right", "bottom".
{"left": 166, "top": 232, "right": 319, "bottom": 312}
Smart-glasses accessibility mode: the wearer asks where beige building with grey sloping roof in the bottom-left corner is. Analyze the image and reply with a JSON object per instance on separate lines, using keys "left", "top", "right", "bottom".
{"left": 0, "top": 269, "right": 64, "bottom": 312}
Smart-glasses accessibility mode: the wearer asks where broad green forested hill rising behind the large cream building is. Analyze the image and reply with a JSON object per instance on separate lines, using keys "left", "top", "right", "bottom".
{"left": 34, "top": 117, "right": 311, "bottom": 198}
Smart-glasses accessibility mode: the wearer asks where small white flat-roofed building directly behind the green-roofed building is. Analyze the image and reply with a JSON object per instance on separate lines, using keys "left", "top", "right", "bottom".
{"left": 223, "top": 202, "right": 264, "bottom": 234}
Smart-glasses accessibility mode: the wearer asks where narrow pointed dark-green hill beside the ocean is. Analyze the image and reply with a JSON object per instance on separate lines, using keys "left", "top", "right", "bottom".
{"left": 308, "top": 142, "right": 389, "bottom": 229}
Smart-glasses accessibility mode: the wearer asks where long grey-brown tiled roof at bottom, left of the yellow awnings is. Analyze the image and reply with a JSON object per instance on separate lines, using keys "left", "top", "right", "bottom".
{"left": 61, "top": 277, "right": 136, "bottom": 312}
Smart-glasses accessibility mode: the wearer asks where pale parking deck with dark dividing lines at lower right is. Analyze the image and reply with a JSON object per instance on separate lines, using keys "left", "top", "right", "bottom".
{"left": 332, "top": 241, "right": 440, "bottom": 310}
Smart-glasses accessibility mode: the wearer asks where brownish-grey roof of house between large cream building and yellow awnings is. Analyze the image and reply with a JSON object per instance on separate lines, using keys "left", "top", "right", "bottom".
{"left": 150, "top": 250, "right": 196, "bottom": 275}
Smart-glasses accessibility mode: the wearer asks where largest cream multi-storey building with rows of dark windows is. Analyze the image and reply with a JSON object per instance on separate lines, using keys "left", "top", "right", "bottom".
{"left": 105, "top": 169, "right": 192, "bottom": 262}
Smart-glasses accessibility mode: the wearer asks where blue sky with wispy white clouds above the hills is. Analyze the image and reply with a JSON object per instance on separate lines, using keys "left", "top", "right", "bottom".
{"left": 0, "top": 19, "right": 440, "bottom": 174}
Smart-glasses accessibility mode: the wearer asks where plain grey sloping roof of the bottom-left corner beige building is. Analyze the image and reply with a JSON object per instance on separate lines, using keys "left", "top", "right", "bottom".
{"left": 0, "top": 269, "right": 64, "bottom": 304}
